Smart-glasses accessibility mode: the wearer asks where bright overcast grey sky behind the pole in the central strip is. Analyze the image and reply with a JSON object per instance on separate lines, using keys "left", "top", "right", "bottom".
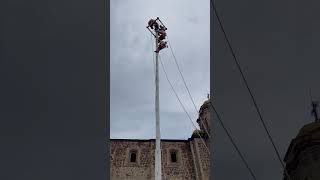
{"left": 110, "top": 0, "right": 210, "bottom": 139}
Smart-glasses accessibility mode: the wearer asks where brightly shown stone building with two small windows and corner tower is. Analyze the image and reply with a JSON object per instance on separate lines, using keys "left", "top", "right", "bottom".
{"left": 110, "top": 100, "right": 210, "bottom": 180}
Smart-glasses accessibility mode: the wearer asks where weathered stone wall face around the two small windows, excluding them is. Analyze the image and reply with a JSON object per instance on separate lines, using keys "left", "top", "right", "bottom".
{"left": 110, "top": 139, "right": 208, "bottom": 180}
